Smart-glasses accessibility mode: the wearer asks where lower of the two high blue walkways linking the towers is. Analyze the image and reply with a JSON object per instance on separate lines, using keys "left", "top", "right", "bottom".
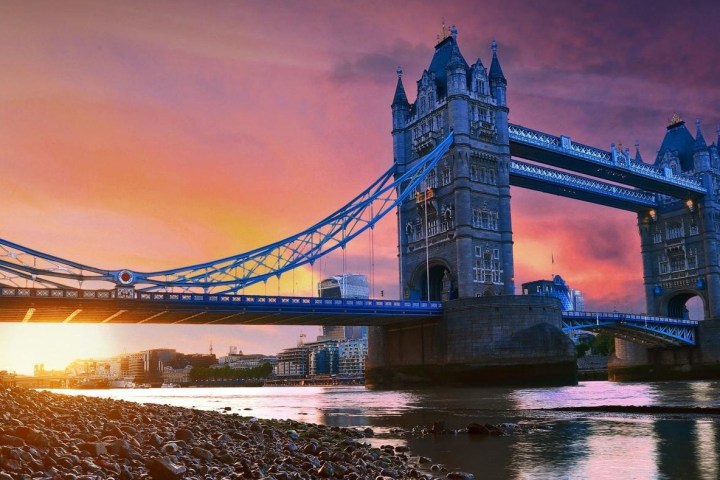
{"left": 510, "top": 160, "right": 657, "bottom": 211}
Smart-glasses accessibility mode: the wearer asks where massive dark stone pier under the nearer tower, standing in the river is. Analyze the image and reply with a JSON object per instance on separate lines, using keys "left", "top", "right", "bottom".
{"left": 365, "top": 295, "right": 577, "bottom": 388}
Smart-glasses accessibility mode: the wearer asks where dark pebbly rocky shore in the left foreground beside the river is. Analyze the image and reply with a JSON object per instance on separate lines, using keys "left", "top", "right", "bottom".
{"left": 0, "top": 388, "right": 473, "bottom": 480}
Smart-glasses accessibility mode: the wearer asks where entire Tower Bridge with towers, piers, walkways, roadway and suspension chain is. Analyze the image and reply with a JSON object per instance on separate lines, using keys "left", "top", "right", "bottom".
{"left": 0, "top": 29, "right": 720, "bottom": 383}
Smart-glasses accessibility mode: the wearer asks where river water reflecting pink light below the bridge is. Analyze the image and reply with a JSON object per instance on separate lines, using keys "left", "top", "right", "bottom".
{"left": 58, "top": 382, "right": 720, "bottom": 480}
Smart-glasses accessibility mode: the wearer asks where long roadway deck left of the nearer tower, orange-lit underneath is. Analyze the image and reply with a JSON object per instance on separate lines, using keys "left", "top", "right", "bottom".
{"left": 0, "top": 287, "right": 442, "bottom": 326}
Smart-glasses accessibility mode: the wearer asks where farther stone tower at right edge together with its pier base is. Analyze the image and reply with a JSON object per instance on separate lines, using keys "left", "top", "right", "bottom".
{"left": 609, "top": 115, "right": 720, "bottom": 380}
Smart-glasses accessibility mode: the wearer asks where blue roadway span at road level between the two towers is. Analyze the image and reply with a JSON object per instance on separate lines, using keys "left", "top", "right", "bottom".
{"left": 562, "top": 311, "right": 698, "bottom": 346}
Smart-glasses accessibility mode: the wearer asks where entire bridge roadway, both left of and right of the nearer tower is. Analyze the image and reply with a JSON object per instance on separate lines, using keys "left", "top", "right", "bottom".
{"left": 0, "top": 287, "right": 698, "bottom": 346}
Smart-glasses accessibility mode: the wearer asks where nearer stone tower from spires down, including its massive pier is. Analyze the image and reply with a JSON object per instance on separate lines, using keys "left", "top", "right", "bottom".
{"left": 365, "top": 27, "right": 577, "bottom": 387}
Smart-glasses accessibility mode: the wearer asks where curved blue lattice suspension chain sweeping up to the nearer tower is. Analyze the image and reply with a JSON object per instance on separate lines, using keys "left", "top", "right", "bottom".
{"left": 0, "top": 132, "right": 453, "bottom": 294}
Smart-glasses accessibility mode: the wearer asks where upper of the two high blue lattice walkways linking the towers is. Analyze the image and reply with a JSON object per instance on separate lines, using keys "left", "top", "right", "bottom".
{"left": 508, "top": 124, "right": 706, "bottom": 195}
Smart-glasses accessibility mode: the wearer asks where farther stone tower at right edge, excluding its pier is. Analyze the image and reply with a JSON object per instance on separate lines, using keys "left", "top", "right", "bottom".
{"left": 638, "top": 115, "right": 720, "bottom": 320}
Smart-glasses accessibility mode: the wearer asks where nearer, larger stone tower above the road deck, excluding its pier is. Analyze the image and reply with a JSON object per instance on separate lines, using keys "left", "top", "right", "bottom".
{"left": 392, "top": 26, "right": 514, "bottom": 300}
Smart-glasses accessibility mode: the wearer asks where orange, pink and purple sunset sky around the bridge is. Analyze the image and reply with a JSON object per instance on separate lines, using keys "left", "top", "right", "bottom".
{"left": 0, "top": 0, "right": 720, "bottom": 373}
